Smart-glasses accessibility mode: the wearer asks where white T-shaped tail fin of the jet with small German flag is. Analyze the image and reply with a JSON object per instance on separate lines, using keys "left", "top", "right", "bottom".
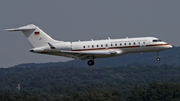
{"left": 6, "top": 24, "right": 62, "bottom": 47}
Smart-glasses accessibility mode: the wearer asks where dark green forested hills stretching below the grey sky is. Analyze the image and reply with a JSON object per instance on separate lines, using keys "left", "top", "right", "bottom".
{"left": 0, "top": 47, "right": 180, "bottom": 101}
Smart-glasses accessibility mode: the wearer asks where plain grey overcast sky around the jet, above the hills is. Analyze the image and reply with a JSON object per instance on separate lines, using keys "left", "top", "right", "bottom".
{"left": 0, "top": 0, "right": 180, "bottom": 67}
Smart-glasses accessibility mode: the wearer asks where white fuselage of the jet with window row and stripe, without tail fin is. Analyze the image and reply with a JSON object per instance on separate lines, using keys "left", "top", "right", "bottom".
{"left": 37, "top": 37, "right": 172, "bottom": 59}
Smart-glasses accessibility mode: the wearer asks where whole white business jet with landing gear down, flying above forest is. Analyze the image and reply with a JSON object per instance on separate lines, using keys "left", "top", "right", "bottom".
{"left": 6, "top": 24, "right": 172, "bottom": 66}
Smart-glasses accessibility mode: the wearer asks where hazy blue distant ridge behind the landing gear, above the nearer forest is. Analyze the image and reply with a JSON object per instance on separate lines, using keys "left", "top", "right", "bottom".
{"left": 14, "top": 47, "right": 180, "bottom": 67}
